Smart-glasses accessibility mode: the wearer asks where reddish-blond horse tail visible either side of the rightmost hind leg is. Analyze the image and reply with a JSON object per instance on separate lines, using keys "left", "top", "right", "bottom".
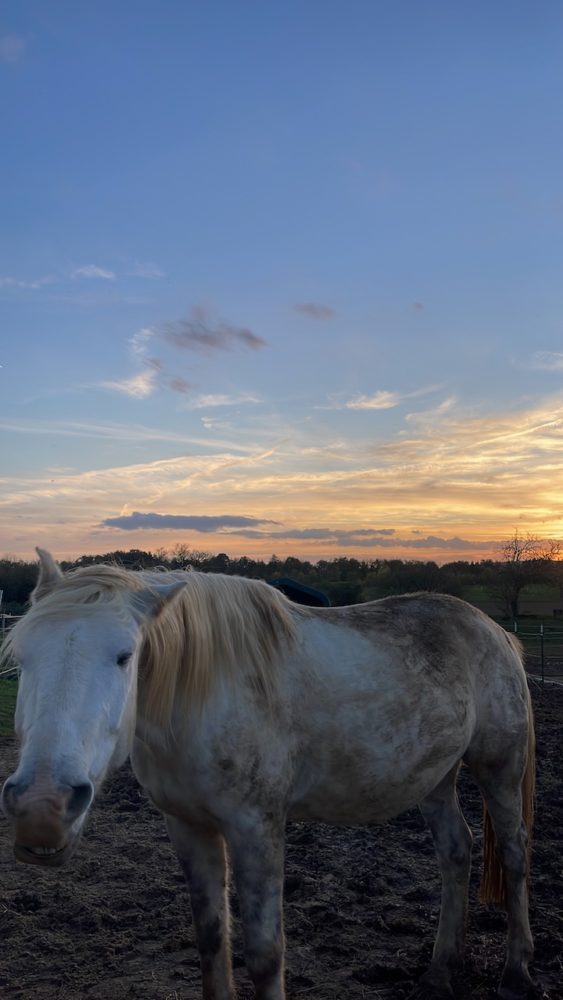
{"left": 479, "top": 689, "right": 536, "bottom": 908}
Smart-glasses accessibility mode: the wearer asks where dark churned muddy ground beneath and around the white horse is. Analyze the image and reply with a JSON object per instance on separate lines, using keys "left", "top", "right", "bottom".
{"left": 0, "top": 685, "right": 563, "bottom": 1000}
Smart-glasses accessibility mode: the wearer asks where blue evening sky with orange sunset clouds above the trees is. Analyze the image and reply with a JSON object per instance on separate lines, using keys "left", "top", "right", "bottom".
{"left": 0, "top": 0, "right": 563, "bottom": 563}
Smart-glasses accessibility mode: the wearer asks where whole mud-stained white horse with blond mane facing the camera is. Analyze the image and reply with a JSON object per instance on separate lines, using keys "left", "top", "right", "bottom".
{"left": 2, "top": 550, "right": 534, "bottom": 1000}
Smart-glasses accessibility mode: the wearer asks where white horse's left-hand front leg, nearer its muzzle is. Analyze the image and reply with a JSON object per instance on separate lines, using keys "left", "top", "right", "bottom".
{"left": 165, "top": 816, "right": 235, "bottom": 1000}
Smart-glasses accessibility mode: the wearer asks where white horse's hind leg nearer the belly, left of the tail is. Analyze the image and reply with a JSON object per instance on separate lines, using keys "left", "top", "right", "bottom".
{"left": 419, "top": 764, "right": 473, "bottom": 997}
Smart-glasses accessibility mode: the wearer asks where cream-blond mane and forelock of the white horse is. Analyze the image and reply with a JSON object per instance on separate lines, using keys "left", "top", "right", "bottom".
{"left": 2, "top": 564, "right": 308, "bottom": 726}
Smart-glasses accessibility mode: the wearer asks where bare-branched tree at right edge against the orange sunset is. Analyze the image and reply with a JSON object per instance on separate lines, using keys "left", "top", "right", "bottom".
{"left": 499, "top": 530, "right": 561, "bottom": 618}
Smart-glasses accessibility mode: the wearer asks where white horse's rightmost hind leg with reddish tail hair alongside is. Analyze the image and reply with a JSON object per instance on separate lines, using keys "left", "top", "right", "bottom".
{"left": 468, "top": 715, "right": 534, "bottom": 1000}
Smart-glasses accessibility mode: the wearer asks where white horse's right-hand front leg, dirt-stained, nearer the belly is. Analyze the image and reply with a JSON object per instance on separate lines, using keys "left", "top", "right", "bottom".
{"left": 226, "top": 817, "right": 285, "bottom": 1000}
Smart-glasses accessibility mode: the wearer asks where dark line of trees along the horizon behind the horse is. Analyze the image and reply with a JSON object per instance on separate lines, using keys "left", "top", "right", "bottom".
{"left": 0, "top": 533, "right": 563, "bottom": 618}
